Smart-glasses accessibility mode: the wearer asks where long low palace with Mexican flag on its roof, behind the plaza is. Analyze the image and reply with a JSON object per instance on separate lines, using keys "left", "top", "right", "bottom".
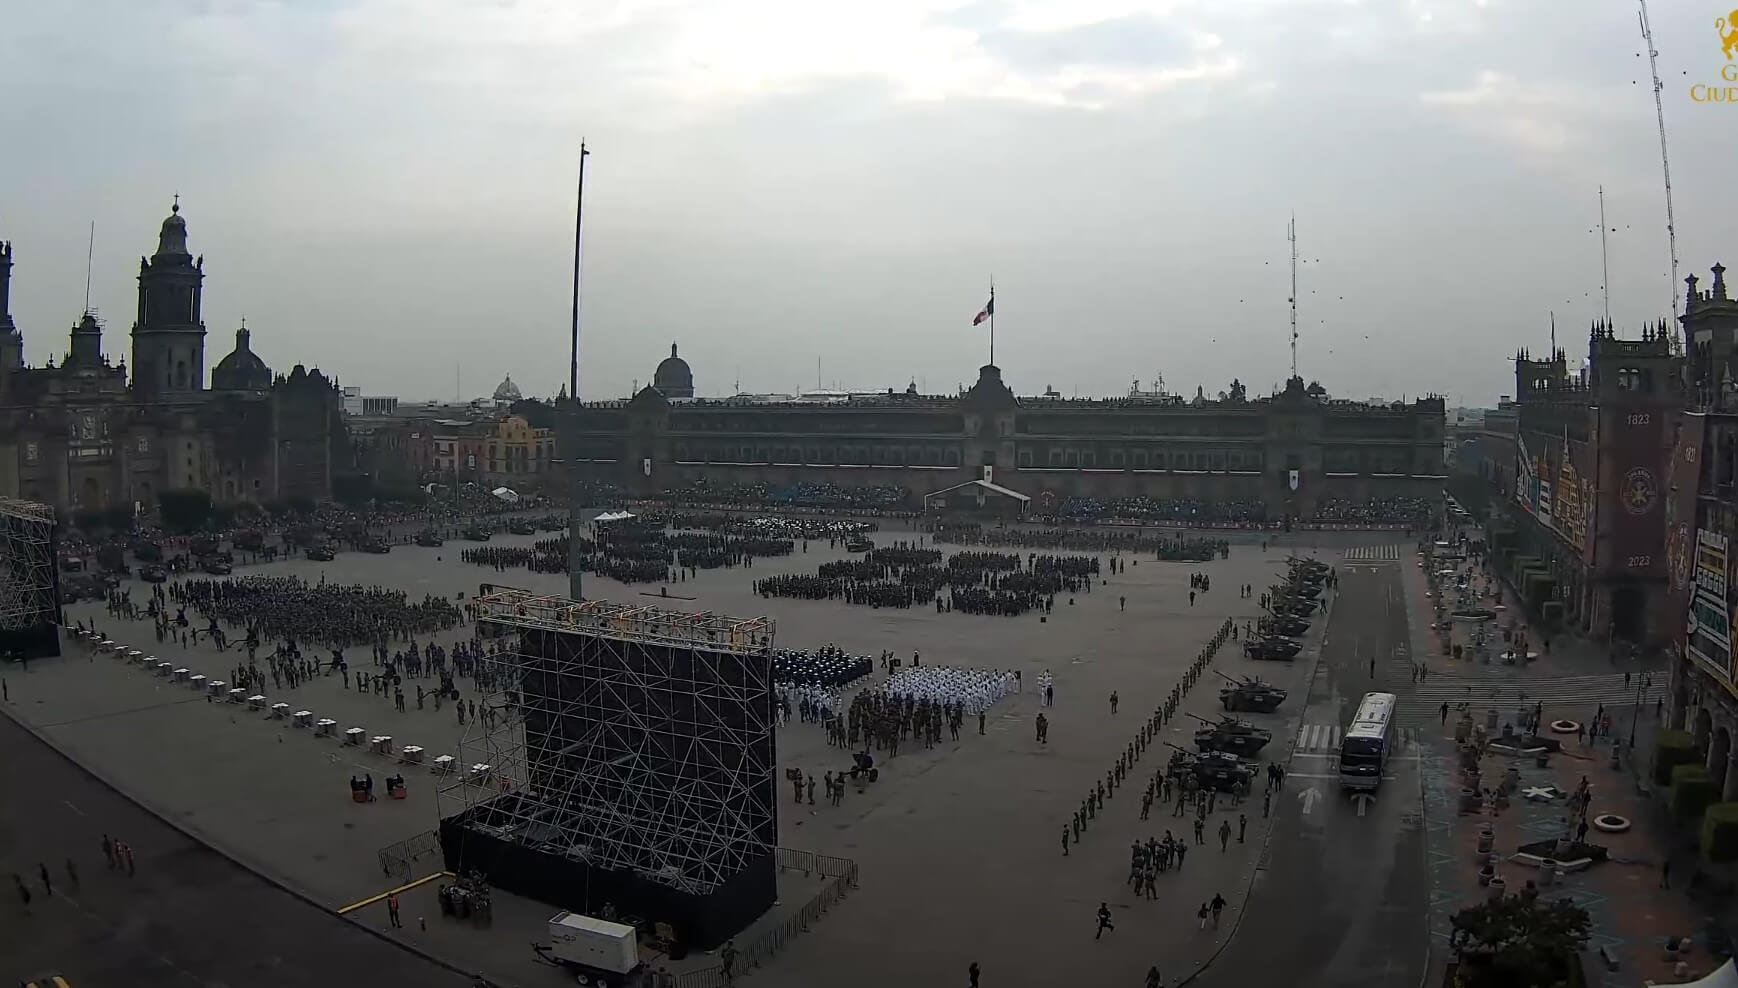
{"left": 574, "top": 358, "right": 1444, "bottom": 520}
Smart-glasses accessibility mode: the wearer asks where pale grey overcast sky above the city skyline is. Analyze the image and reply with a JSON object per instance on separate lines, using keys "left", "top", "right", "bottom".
{"left": 0, "top": 0, "right": 1738, "bottom": 404}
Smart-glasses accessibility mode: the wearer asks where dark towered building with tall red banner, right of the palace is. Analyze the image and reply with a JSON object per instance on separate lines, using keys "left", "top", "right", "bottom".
{"left": 1502, "top": 316, "right": 1684, "bottom": 644}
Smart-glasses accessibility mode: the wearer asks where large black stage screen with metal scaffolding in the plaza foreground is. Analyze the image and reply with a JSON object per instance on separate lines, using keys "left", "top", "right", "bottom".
{"left": 440, "top": 584, "right": 779, "bottom": 950}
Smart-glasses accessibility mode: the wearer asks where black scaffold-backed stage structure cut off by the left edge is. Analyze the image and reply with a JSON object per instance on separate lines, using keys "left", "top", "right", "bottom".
{"left": 0, "top": 497, "right": 63, "bottom": 659}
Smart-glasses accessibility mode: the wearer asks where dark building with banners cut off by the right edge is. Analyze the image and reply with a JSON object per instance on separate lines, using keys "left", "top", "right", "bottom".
{"left": 1663, "top": 264, "right": 1738, "bottom": 802}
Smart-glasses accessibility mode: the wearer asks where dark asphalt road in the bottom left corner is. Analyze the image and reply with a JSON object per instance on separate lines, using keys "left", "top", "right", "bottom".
{"left": 0, "top": 702, "right": 468, "bottom": 988}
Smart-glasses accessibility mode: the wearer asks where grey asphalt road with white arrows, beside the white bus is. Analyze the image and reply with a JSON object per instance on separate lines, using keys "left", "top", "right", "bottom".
{"left": 1194, "top": 565, "right": 1429, "bottom": 988}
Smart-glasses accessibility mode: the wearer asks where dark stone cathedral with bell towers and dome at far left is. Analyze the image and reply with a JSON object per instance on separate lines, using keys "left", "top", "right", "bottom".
{"left": 0, "top": 202, "right": 348, "bottom": 511}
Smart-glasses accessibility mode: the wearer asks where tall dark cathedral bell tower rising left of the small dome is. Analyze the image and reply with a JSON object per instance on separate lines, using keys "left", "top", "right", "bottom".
{"left": 132, "top": 197, "right": 205, "bottom": 398}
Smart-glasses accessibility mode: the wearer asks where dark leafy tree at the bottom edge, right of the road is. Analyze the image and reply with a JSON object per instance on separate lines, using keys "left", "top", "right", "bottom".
{"left": 1448, "top": 892, "right": 1590, "bottom": 988}
